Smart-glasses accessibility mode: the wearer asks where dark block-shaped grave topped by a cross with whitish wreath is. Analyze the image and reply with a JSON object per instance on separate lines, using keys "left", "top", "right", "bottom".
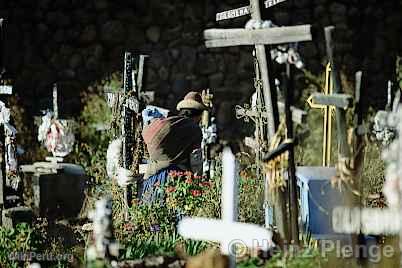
{"left": 21, "top": 84, "right": 88, "bottom": 219}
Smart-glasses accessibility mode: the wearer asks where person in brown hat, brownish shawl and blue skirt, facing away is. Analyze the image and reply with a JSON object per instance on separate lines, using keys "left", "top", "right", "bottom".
{"left": 139, "top": 91, "right": 208, "bottom": 203}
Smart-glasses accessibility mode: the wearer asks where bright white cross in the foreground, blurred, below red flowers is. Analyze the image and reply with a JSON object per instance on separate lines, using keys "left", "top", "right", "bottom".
{"left": 178, "top": 148, "right": 274, "bottom": 267}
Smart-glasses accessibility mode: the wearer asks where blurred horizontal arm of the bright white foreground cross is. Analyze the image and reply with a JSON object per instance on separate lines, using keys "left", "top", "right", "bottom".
{"left": 178, "top": 218, "right": 274, "bottom": 251}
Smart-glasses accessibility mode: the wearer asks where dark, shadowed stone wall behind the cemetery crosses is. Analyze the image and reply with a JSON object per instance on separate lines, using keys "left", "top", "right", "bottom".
{"left": 0, "top": 0, "right": 402, "bottom": 138}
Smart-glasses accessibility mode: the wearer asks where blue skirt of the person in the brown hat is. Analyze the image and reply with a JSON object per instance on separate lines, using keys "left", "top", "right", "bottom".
{"left": 140, "top": 165, "right": 182, "bottom": 204}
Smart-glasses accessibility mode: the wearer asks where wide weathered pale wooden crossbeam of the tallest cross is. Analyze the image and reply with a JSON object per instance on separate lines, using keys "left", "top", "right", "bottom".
{"left": 204, "top": 25, "right": 312, "bottom": 48}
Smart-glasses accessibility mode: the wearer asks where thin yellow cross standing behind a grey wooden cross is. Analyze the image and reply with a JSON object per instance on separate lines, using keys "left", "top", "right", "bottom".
{"left": 307, "top": 63, "right": 335, "bottom": 167}
